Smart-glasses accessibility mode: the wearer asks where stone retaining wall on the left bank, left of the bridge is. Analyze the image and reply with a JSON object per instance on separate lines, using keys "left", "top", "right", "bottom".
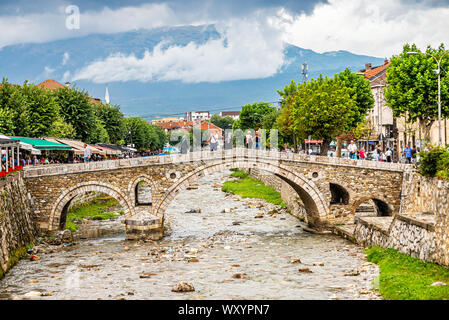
{"left": 0, "top": 173, "right": 37, "bottom": 278}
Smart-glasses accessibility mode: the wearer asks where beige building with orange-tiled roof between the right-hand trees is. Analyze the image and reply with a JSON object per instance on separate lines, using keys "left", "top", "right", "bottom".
{"left": 359, "top": 60, "right": 395, "bottom": 150}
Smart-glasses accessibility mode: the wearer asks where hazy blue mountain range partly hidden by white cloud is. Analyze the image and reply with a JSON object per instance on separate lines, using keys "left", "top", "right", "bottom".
{"left": 0, "top": 25, "right": 384, "bottom": 120}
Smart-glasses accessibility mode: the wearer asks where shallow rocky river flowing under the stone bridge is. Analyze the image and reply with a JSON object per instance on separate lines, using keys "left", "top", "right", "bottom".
{"left": 0, "top": 172, "right": 380, "bottom": 299}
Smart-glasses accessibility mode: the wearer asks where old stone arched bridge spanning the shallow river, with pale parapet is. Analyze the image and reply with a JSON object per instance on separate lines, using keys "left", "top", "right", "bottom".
{"left": 24, "top": 148, "right": 410, "bottom": 238}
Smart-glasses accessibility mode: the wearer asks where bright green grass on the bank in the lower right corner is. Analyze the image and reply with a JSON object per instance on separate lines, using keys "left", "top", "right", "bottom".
{"left": 366, "top": 247, "right": 449, "bottom": 300}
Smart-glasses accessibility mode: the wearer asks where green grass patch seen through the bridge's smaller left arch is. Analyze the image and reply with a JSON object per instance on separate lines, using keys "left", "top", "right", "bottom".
{"left": 66, "top": 196, "right": 119, "bottom": 232}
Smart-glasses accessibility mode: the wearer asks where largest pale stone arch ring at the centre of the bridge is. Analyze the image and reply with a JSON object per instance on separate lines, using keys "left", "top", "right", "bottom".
{"left": 153, "top": 159, "right": 329, "bottom": 226}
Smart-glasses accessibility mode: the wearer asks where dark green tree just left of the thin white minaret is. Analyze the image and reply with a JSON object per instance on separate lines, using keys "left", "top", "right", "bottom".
{"left": 51, "top": 87, "right": 95, "bottom": 142}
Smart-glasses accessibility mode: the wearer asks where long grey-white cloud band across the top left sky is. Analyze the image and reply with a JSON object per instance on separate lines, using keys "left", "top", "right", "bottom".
{"left": 0, "top": 1, "right": 201, "bottom": 48}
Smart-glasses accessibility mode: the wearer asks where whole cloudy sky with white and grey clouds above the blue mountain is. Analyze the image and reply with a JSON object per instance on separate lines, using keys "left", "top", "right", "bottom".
{"left": 0, "top": 0, "right": 449, "bottom": 82}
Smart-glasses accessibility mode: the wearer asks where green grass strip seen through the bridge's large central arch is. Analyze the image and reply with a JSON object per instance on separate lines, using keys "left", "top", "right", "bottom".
{"left": 221, "top": 170, "right": 286, "bottom": 208}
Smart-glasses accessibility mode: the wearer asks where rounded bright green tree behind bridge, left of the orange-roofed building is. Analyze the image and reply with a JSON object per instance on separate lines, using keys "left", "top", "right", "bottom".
{"left": 292, "top": 75, "right": 357, "bottom": 155}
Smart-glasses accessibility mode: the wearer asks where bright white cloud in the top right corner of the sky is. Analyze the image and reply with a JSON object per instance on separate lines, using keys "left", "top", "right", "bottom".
{"left": 273, "top": 0, "right": 449, "bottom": 57}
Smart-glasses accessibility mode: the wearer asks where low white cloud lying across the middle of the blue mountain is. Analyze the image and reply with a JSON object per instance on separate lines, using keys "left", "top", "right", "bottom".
{"left": 72, "top": 17, "right": 285, "bottom": 83}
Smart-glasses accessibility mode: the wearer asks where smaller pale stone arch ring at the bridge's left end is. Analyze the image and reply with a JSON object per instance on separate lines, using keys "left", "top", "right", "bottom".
{"left": 48, "top": 182, "right": 134, "bottom": 231}
